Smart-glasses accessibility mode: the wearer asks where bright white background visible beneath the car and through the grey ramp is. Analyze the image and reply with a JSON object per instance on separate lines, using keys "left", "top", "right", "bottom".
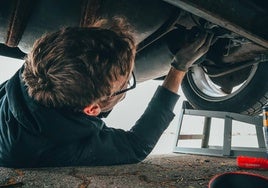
{"left": 0, "top": 56, "right": 257, "bottom": 154}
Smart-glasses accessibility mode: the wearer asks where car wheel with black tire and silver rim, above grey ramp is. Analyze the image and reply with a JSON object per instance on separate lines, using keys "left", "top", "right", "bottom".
{"left": 182, "top": 62, "right": 268, "bottom": 115}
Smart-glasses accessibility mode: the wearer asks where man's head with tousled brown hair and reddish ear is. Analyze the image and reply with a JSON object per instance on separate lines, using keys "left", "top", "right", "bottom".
{"left": 23, "top": 19, "right": 135, "bottom": 115}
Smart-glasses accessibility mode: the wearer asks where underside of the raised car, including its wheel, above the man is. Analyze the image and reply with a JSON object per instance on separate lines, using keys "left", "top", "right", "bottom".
{"left": 0, "top": 0, "right": 268, "bottom": 115}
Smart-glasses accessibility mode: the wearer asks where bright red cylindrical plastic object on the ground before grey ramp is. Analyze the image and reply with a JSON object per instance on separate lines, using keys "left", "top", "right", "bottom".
{"left": 237, "top": 156, "right": 268, "bottom": 169}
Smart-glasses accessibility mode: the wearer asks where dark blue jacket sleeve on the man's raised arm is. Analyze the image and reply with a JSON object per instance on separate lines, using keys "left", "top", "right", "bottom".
{"left": 70, "top": 86, "right": 179, "bottom": 165}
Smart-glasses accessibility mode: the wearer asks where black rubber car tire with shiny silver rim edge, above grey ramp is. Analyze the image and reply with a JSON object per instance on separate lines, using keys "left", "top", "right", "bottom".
{"left": 182, "top": 62, "right": 268, "bottom": 115}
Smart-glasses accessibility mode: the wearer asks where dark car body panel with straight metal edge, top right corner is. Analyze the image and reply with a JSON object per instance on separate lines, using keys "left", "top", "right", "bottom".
{"left": 164, "top": 0, "right": 268, "bottom": 48}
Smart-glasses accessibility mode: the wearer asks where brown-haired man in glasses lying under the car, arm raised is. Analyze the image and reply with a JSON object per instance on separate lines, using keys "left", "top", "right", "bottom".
{"left": 0, "top": 18, "right": 211, "bottom": 168}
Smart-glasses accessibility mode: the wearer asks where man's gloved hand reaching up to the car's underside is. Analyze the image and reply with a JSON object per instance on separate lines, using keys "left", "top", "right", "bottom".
{"left": 171, "top": 33, "right": 213, "bottom": 72}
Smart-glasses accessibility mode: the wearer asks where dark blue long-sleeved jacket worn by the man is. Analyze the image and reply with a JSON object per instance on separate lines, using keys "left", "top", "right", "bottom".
{"left": 0, "top": 66, "right": 179, "bottom": 168}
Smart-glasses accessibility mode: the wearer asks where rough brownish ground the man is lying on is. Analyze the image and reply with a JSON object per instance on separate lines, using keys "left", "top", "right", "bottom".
{"left": 0, "top": 154, "right": 268, "bottom": 188}
